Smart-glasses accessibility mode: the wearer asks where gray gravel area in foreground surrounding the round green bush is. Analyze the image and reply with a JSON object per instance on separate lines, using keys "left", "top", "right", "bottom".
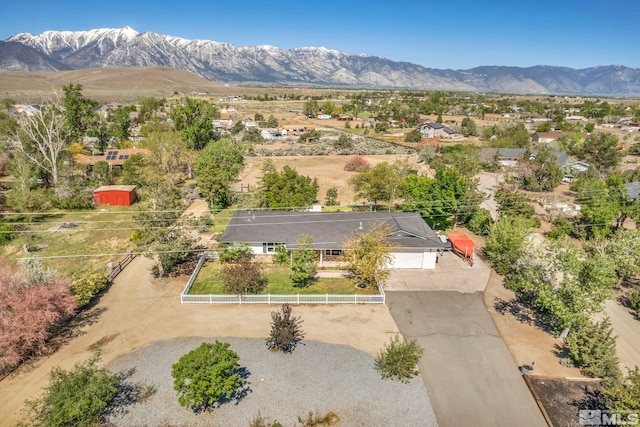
{"left": 109, "top": 337, "right": 437, "bottom": 427}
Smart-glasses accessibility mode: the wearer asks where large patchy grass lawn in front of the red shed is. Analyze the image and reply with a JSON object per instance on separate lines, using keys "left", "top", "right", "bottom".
{"left": 0, "top": 206, "right": 136, "bottom": 276}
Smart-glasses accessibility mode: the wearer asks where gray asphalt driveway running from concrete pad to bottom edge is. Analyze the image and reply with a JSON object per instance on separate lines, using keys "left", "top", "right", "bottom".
{"left": 386, "top": 290, "right": 547, "bottom": 427}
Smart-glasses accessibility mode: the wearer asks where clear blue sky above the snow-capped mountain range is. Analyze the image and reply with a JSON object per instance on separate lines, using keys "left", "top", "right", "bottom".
{"left": 0, "top": 0, "right": 640, "bottom": 69}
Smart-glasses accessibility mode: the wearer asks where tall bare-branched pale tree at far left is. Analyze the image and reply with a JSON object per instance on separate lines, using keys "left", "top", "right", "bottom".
{"left": 9, "top": 100, "right": 69, "bottom": 187}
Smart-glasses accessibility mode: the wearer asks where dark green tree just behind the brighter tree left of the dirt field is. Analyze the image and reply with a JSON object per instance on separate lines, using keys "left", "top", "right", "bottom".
{"left": 171, "top": 97, "right": 220, "bottom": 150}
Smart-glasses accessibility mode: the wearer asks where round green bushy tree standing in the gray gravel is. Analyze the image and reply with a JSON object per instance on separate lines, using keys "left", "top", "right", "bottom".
{"left": 171, "top": 340, "right": 246, "bottom": 411}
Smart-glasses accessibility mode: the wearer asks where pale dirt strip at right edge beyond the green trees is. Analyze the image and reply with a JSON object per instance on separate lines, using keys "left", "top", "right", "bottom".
{"left": 604, "top": 300, "right": 640, "bottom": 370}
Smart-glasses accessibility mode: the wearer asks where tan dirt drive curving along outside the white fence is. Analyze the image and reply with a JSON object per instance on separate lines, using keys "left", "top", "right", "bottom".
{"left": 0, "top": 257, "right": 398, "bottom": 426}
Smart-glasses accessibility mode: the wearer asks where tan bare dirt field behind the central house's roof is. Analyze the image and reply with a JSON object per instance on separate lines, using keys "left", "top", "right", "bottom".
{"left": 236, "top": 155, "right": 424, "bottom": 205}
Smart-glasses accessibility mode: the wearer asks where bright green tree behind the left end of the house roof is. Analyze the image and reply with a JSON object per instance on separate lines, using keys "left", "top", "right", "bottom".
{"left": 195, "top": 138, "right": 244, "bottom": 208}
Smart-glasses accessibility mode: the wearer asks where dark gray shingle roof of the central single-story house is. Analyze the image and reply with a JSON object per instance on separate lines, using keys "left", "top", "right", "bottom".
{"left": 219, "top": 210, "right": 449, "bottom": 250}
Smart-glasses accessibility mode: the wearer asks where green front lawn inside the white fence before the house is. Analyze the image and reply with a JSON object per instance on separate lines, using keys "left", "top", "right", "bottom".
{"left": 189, "top": 261, "right": 378, "bottom": 295}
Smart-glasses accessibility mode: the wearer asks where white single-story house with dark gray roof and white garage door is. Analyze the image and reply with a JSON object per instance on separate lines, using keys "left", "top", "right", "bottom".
{"left": 218, "top": 210, "right": 451, "bottom": 269}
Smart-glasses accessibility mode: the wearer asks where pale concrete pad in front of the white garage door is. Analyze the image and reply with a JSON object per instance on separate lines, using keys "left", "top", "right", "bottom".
{"left": 384, "top": 252, "right": 491, "bottom": 293}
